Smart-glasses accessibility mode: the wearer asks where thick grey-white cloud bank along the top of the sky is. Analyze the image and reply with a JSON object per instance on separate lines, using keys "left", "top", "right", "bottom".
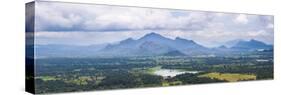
{"left": 35, "top": 2, "right": 273, "bottom": 32}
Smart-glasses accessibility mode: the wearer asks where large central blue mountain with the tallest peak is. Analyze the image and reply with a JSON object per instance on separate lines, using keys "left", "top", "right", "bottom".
{"left": 96, "top": 32, "right": 207, "bottom": 56}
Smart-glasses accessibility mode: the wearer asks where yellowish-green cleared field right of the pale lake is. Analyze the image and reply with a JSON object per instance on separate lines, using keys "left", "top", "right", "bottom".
{"left": 198, "top": 73, "right": 256, "bottom": 82}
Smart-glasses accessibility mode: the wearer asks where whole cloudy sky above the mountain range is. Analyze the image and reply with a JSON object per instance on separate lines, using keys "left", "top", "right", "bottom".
{"left": 31, "top": 2, "right": 274, "bottom": 47}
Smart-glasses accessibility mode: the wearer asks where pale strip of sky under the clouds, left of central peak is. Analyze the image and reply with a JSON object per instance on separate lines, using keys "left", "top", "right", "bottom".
{"left": 35, "top": 31, "right": 151, "bottom": 45}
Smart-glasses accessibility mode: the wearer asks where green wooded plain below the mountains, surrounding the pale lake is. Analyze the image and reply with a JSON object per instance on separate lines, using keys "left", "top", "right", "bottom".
{"left": 29, "top": 53, "right": 273, "bottom": 93}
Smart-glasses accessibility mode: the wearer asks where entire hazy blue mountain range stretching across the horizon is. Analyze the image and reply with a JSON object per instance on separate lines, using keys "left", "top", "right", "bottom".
{"left": 35, "top": 32, "right": 273, "bottom": 57}
